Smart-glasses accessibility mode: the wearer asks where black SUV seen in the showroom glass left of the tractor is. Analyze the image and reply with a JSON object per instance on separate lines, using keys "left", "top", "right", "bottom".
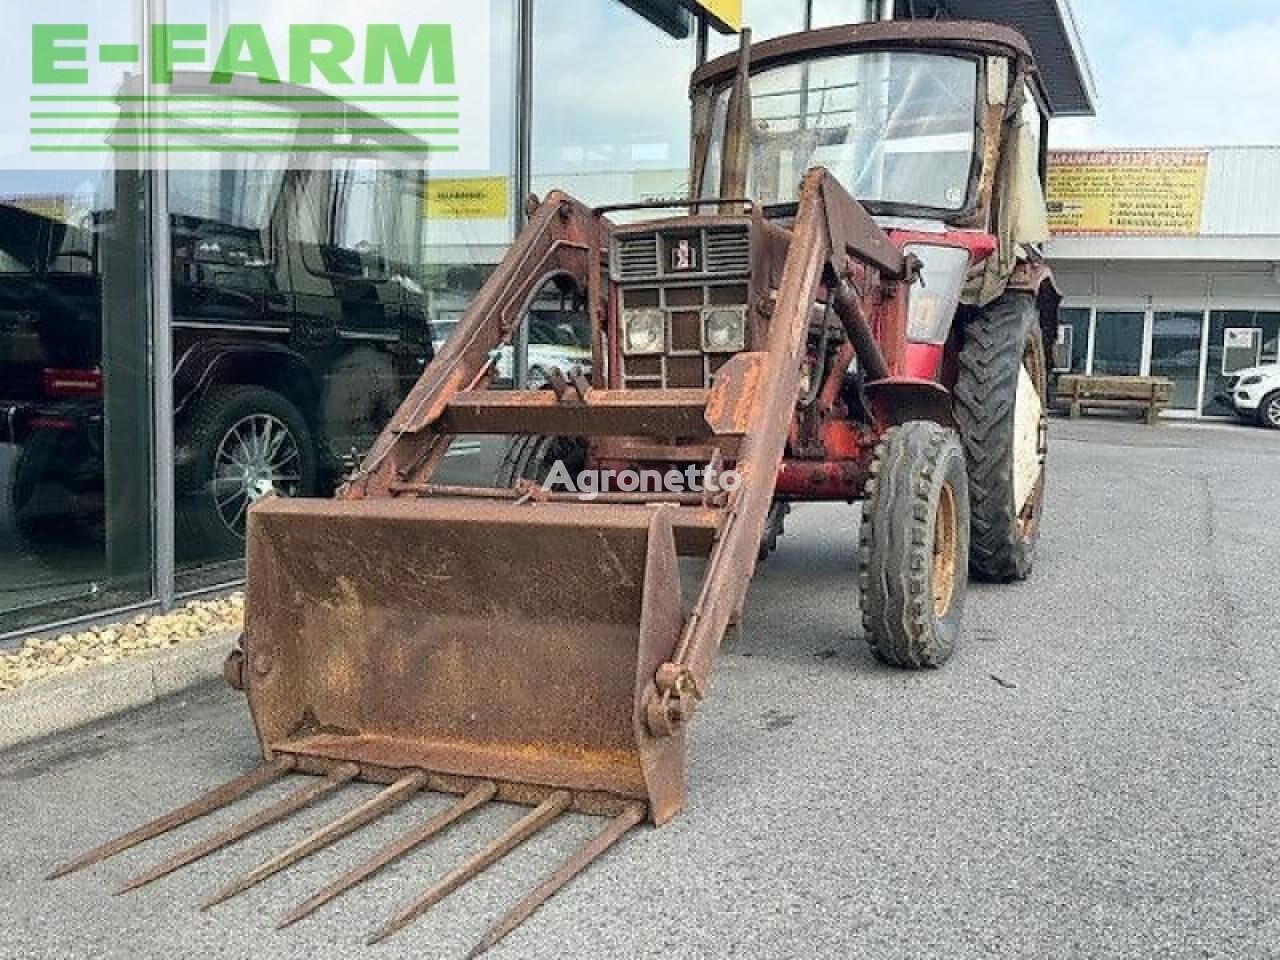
{"left": 0, "top": 160, "right": 433, "bottom": 558}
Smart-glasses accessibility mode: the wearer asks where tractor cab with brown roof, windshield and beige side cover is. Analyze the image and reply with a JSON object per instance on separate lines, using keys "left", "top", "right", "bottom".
{"left": 691, "top": 20, "right": 1056, "bottom": 339}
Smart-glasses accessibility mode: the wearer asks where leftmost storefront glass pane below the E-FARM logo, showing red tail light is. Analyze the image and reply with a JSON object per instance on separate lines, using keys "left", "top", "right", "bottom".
{"left": 0, "top": 166, "right": 152, "bottom": 634}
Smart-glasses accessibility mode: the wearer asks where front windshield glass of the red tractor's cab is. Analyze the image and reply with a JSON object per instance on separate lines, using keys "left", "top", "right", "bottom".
{"left": 703, "top": 52, "right": 978, "bottom": 211}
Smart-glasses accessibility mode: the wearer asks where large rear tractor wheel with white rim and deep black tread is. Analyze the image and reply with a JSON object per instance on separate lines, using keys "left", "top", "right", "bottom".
{"left": 955, "top": 292, "right": 1048, "bottom": 582}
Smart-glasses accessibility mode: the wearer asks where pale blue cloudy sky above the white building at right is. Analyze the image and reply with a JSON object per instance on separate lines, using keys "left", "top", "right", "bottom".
{"left": 1051, "top": 0, "right": 1280, "bottom": 147}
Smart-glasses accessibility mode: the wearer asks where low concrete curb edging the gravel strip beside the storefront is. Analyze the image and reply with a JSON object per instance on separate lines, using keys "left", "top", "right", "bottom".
{"left": 0, "top": 632, "right": 238, "bottom": 750}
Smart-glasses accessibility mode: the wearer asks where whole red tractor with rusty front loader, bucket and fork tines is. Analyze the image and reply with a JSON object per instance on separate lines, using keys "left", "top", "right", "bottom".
{"left": 52, "top": 22, "right": 1057, "bottom": 952}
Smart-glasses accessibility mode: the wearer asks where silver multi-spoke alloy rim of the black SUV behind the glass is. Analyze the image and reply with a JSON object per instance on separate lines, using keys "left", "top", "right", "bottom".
{"left": 212, "top": 413, "right": 302, "bottom": 538}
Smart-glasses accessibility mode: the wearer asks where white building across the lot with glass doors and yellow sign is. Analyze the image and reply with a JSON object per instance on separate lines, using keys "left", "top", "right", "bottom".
{"left": 1047, "top": 147, "right": 1280, "bottom": 417}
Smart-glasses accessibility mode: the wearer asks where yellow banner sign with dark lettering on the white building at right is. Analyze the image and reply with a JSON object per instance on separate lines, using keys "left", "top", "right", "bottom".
{"left": 1047, "top": 150, "right": 1208, "bottom": 237}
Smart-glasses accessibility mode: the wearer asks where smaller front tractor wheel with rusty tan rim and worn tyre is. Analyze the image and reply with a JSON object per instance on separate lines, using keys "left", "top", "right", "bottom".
{"left": 859, "top": 421, "right": 969, "bottom": 669}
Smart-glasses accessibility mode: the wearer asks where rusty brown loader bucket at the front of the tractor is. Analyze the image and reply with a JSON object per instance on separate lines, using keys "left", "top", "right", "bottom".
{"left": 235, "top": 498, "right": 684, "bottom": 823}
